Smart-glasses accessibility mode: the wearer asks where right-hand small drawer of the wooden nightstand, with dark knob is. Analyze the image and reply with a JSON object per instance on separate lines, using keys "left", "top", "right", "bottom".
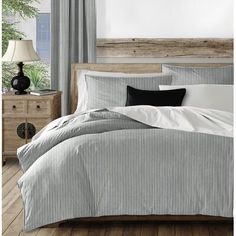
{"left": 28, "top": 100, "right": 51, "bottom": 115}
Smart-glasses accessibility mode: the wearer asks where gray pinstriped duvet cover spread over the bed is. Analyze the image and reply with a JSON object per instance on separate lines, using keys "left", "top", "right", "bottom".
{"left": 18, "top": 112, "right": 233, "bottom": 230}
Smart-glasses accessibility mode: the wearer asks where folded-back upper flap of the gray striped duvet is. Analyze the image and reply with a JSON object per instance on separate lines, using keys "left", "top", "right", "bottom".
{"left": 17, "top": 110, "right": 151, "bottom": 172}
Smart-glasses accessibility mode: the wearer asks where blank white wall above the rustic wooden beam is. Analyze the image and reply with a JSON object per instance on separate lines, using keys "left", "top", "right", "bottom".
{"left": 96, "top": 0, "right": 233, "bottom": 38}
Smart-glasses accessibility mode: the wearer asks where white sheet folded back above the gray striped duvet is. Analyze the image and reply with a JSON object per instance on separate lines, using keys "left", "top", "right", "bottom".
{"left": 109, "top": 106, "right": 233, "bottom": 137}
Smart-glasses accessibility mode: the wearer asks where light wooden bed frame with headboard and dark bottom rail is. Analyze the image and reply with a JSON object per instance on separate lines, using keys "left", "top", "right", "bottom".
{"left": 47, "top": 63, "right": 233, "bottom": 227}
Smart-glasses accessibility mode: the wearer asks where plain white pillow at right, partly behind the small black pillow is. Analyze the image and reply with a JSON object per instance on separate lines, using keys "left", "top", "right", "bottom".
{"left": 159, "top": 84, "right": 233, "bottom": 113}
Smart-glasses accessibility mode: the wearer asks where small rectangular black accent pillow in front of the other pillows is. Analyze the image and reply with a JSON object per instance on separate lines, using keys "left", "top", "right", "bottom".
{"left": 126, "top": 86, "right": 186, "bottom": 106}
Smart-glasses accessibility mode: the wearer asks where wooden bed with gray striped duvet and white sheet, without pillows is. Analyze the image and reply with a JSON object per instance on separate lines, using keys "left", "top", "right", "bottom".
{"left": 18, "top": 64, "right": 233, "bottom": 231}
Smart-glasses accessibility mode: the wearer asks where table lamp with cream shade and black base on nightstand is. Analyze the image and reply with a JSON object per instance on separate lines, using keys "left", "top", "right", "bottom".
{"left": 2, "top": 39, "right": 40, "bottom": 95}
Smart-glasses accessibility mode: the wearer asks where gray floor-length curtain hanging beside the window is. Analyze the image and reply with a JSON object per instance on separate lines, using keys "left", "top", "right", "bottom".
{"left": 51, "top": 0, "right": 96, "bottom": 115}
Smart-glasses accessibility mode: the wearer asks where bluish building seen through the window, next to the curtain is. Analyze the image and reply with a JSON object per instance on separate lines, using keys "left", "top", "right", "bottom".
{"left": 36, "top": 13, "right": 50, "bottom": 63}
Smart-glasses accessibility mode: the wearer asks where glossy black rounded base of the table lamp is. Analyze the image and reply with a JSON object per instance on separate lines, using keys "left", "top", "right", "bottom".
{"left": 11, "top": 62, "right": 30, "bottom": 95}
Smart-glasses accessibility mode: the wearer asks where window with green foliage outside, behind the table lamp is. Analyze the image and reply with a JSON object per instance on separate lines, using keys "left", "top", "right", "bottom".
{"left": 2, "top": 0, "right": 51, "bottom": 91}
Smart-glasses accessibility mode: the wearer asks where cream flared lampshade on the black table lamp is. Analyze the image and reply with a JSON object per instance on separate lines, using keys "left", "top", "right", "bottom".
{"left": 2, "top": 40, "right": 40, "bottom": 62}
